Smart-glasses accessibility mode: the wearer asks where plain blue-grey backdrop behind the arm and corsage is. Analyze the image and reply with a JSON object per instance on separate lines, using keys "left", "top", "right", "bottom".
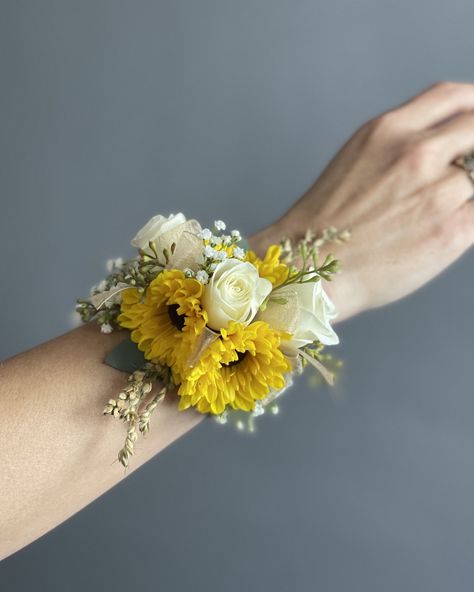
{"left": 0, "top": 0, "right": 474, "bottom": 592}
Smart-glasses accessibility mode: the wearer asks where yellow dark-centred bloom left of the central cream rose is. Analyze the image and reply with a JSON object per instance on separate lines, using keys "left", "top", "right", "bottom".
{"left": 118, "top": 269, "right": 207, "bottom": 381}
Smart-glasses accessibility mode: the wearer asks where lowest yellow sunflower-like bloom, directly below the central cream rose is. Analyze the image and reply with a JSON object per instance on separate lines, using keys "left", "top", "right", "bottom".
{"left": 178, "top": 321, "right": 291, "bottom": 414}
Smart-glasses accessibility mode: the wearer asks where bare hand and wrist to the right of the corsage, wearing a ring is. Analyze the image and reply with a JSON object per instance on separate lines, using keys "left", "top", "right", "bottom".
{"left": 251, "top": 83, "right": 474, "bottom": 319}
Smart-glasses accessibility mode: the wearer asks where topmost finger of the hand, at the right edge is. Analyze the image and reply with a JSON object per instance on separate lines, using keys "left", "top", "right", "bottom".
{"left": 393, "top": 82, "right": 474, "bottom": 130}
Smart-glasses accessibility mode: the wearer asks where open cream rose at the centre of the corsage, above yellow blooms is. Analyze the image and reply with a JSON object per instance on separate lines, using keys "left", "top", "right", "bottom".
{"left": 201, "top": 259, "right": 272, "bottom": 331}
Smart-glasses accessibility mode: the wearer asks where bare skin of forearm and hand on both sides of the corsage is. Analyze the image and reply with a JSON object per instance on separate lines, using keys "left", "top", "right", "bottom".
{"left": 0, "top": 83, "right": 474, "bottom": 558}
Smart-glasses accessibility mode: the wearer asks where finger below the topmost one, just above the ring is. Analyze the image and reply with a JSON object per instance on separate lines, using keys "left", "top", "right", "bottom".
{"left": 421, "top": 110, "right": 474, "bottom": 165}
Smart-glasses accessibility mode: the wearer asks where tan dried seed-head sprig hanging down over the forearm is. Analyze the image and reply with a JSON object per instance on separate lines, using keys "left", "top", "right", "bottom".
{"left": 104, "top": 362, "right": 171, "bottom": 468}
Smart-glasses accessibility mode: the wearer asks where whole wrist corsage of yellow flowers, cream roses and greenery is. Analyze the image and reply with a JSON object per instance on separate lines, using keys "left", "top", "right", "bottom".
{"left": 76, "top": 214, "right": 347, "bottom": 467}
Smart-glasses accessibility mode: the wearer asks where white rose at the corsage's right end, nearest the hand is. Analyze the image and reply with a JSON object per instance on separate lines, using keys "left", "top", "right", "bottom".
{"left": 275, "top": 280, "right": 339, "bottom": 355}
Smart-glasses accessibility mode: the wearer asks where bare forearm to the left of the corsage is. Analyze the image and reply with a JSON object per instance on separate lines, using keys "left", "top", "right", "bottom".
{"left": 0, "top": 324, "right": 204, "bottom": 557}
